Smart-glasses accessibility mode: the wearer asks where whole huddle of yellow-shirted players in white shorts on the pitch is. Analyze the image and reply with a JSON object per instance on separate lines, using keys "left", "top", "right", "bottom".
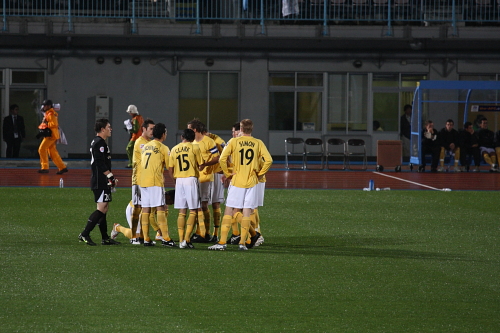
{"left": 111, "top": 119, "right": 272, "bottom": 250}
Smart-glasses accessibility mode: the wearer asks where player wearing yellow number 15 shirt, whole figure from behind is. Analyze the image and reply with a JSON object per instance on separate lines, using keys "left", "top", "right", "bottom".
{"left": 168, "top": 129, "right": 203, "bottom": 249}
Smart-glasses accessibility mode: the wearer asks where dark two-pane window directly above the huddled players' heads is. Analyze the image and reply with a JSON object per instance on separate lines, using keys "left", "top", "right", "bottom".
{"left": 178, "top": 72, "right": 239, "bottom": 131}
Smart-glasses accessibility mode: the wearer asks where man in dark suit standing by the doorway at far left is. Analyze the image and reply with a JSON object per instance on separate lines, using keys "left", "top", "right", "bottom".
{"left": 3, "top": 104, "right": 26, "bottom": 158}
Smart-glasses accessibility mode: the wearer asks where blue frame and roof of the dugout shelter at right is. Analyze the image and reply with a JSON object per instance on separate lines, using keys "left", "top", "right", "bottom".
{"left": 410, "top": 80, "right": 500, "bottom": 165}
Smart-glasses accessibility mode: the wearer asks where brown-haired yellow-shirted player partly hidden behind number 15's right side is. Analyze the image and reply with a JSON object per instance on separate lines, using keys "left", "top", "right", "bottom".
{"left": 187, "top": 118, "right": 220, "bottom": 243}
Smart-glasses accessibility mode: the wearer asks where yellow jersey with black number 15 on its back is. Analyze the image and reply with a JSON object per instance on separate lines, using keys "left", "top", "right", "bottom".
{"left": 168, "top": 142, "right": 203, "bottom": 179}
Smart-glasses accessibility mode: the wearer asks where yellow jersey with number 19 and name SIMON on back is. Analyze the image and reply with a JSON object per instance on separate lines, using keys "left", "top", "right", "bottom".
{"left": 219, "top": 136, "right": 273, "bottom": 188}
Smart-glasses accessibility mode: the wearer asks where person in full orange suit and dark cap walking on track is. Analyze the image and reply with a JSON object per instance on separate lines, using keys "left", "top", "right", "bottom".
{"left": 38, "top": 99, "right": 68, "bottom": 175}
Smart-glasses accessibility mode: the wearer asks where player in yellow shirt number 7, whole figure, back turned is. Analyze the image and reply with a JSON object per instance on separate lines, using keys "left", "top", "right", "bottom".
{"left": 139, "top": 123, "right": 175, "bottom": 247}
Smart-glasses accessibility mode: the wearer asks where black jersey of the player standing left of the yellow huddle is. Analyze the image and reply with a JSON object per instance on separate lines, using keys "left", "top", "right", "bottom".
{"left": 90, "top": 136, "right": 111, "bottom": 190}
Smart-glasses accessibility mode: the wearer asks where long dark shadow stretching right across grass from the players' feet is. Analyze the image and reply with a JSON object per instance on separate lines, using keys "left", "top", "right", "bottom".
{"left": 255, "top": 235, "right": 481, "bottom": 262}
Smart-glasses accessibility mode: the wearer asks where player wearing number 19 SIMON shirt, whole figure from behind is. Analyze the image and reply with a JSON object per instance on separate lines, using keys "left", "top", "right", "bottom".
{"left": 208, "top": 119, "right": 273, "bottom": 250}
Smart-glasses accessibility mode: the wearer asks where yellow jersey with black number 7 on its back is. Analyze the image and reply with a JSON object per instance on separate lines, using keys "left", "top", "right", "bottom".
{"left": 139, "top": 140, "right": 170, "bottom": 187}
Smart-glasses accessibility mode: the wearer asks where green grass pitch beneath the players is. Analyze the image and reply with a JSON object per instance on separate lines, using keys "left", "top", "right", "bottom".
{"left": 0, "top": 188, "right": 500, "bottom": 333}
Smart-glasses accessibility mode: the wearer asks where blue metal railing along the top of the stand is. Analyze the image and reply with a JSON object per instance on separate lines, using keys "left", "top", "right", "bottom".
{"left": 0, "top": 0, "right": 500, "bottom": 34}
